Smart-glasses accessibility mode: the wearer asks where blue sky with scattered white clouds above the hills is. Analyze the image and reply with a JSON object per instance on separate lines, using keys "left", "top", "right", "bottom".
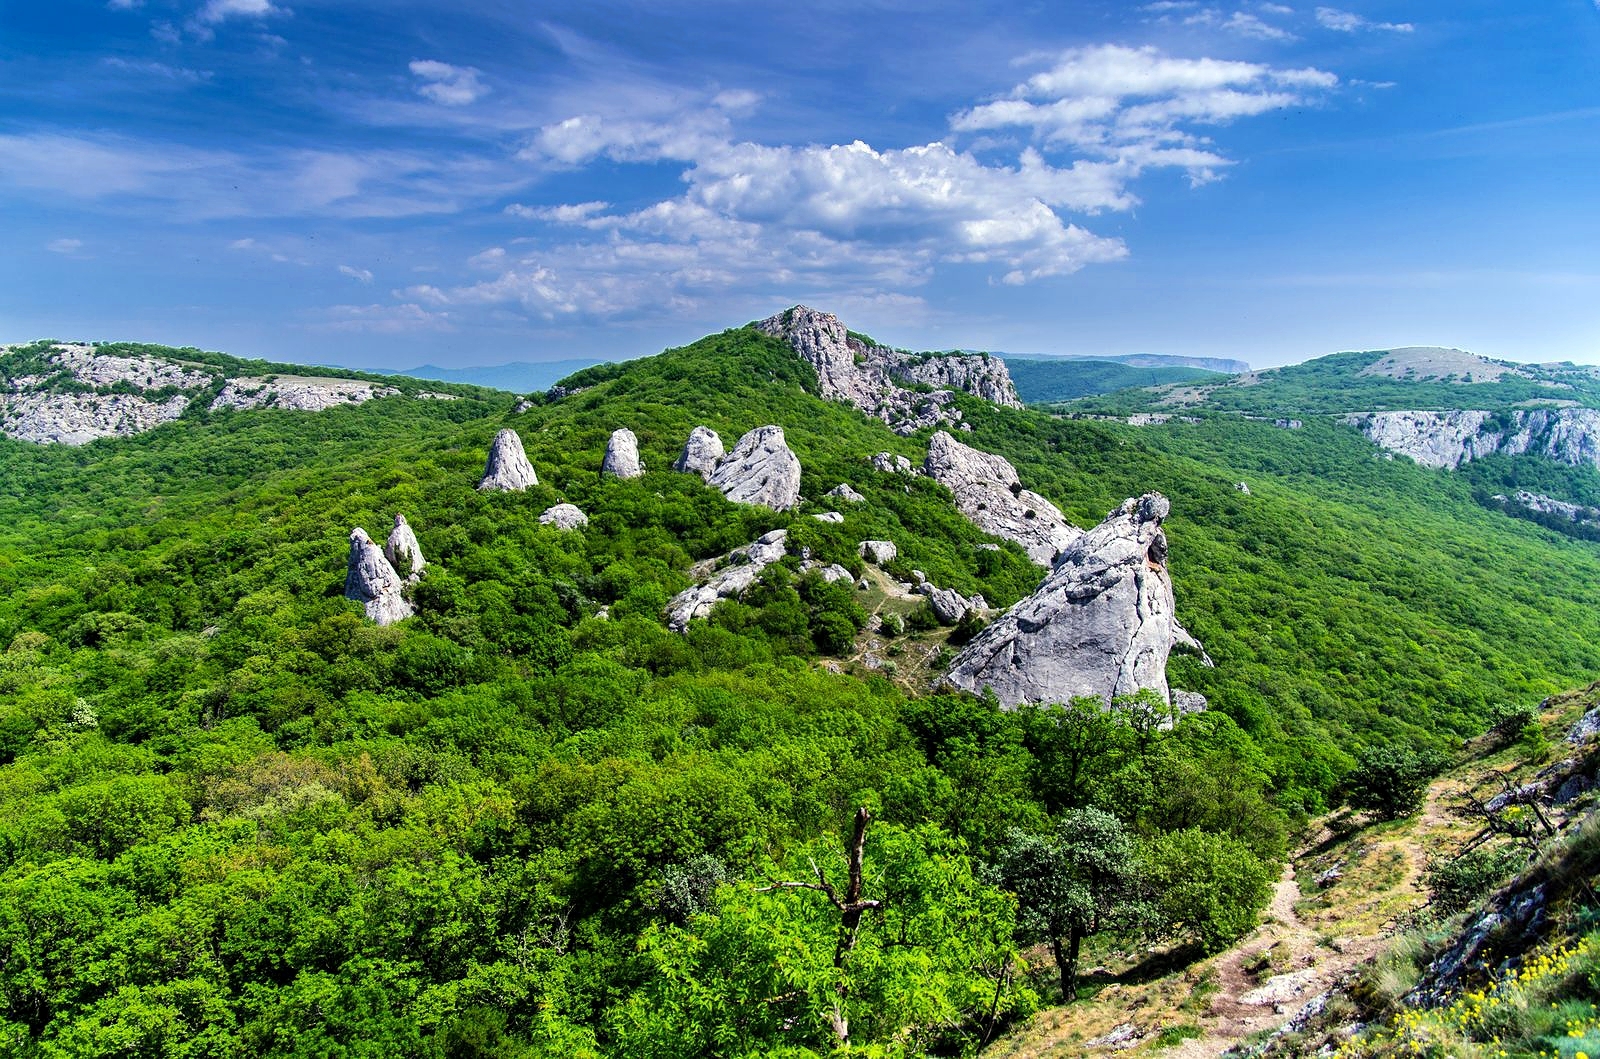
{"left": 0, "top": 0, "right": 1600, "bottom": 366}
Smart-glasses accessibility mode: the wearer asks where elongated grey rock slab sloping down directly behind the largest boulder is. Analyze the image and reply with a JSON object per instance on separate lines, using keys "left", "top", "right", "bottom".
{"left": 923, "top": 430, "right": 1083, "bottom": 566}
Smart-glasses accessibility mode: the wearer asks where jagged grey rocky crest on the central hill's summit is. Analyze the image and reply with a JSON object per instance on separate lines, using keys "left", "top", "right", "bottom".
{"left": 755, "top": 306, "right": 1022, "bottom": 434}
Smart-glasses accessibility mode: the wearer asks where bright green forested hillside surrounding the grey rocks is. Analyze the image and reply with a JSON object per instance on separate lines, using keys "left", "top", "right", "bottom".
{"left": 0, "top": 328, "right": 1600, "bottom": 1057}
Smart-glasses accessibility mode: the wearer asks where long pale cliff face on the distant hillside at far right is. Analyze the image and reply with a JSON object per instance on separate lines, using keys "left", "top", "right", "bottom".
{"left": 1344, "top": 408, "right": 1600, "bottom": 469}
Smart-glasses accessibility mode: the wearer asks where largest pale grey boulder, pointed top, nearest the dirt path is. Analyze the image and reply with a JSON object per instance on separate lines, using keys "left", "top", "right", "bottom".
{"left": 949, "top": 493, "right": 1200, "bottom": 707}
